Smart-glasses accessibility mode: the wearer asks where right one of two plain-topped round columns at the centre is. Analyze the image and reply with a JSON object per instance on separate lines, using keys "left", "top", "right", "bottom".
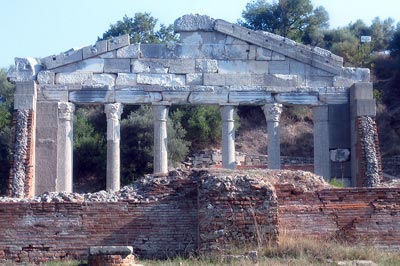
{"left": 221, "top": 105, "right": 236, "bottom": 169}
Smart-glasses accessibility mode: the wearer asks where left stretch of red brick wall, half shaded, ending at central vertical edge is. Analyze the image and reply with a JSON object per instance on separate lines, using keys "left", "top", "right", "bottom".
{"left": 0, "top": 179, "right": 198, "bottom": 263}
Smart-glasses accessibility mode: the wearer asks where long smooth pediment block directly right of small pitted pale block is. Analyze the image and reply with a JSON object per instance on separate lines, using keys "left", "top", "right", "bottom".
{"left": 218, "top": 60, "right": 269, "bottom": 74}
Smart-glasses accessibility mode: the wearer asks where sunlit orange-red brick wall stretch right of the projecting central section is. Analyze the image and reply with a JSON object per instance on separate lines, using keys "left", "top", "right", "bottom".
{"left": 276, "top": 184, "right": 400, "bottom": 250}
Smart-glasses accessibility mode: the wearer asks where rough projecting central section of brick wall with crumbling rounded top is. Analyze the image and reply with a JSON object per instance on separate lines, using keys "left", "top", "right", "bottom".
{"left": 198, "top": 170, "right": 278, "bottom": 252}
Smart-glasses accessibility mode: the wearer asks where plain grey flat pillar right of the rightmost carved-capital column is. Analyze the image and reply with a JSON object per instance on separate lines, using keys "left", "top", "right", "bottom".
{"left": 313, "top": 105, "right": 331, "bottom": 181}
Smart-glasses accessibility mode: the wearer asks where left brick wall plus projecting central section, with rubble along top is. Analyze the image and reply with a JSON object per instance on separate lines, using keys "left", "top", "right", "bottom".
{"left": 0, "top": 172, "right": 277, "bottom": 263}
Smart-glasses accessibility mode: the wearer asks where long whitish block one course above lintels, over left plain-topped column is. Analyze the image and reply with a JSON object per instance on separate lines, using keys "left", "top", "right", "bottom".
{"left": 137, "top": 73, "right": 186, "bottom": 86}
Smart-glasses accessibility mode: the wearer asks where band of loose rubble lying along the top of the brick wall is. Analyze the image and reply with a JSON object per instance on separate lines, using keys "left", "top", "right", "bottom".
{"left": 0, "top": 169, "right": 331, "bottom": 203}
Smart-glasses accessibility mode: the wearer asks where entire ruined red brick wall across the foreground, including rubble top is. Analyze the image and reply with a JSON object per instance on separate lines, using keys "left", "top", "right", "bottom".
{"left": 0, "top": 170, "right": 400, "bottom": 263}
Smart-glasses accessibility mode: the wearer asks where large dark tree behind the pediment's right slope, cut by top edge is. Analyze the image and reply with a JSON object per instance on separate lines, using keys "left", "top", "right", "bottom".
{"left": 239, "top": 0, "right": 329, "bottom": 42}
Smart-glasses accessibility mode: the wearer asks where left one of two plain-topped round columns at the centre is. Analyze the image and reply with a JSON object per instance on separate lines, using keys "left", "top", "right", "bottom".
{"left": 153, "top": 102, "right": 170, "bottom": 175}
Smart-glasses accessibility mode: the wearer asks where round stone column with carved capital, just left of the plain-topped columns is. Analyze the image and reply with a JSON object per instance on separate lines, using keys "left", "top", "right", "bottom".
{"left": 104, "top": 103, "right": 123, "bottom": 191}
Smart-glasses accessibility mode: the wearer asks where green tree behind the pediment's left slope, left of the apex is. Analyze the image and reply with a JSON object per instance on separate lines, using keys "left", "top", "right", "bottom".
{"left": 99, "top": 13, "right": 176, "bottom": 43}
